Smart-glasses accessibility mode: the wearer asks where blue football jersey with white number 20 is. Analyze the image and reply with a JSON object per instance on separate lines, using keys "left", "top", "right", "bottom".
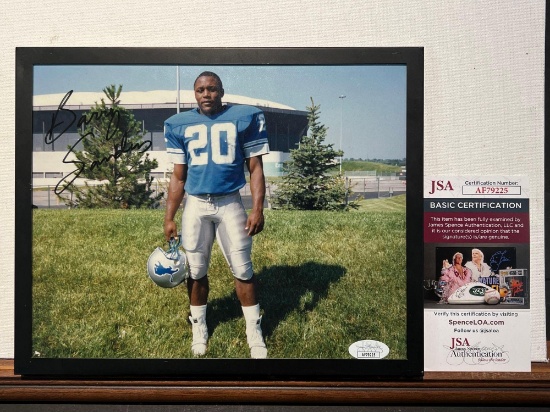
{"left": 164, "top": 105, "right": 269, "bottom": 195}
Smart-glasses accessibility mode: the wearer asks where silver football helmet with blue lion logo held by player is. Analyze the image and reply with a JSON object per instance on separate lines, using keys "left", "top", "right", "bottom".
{"left": 147, "top": 236, "right": 189, "bottom": 288}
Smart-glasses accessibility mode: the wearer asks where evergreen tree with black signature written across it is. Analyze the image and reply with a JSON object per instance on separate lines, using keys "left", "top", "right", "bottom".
{"left": 64, "top": 85, "right": 163, "bottom": 209}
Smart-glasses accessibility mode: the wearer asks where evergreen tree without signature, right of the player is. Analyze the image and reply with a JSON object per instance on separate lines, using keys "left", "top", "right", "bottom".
{"left": 272, "top": 99, "right": 356, "bottom": 210}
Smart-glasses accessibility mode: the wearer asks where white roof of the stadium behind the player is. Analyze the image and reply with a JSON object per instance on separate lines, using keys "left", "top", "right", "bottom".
{"left": 33, "top": 90, "right": 295, "bottom": 110}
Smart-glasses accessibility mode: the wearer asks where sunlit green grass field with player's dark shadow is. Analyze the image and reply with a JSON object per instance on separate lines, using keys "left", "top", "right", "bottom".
{"left": 33, "top": 196, "right": 406, "bottom": 359}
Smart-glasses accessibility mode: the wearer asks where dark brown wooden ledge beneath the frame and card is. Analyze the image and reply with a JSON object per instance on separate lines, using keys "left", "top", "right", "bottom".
{"left": 0, "top": 350, "right": 550, "bottom": 406}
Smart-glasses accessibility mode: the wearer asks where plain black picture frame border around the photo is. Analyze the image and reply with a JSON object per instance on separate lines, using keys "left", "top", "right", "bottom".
{"left": 14, "top": 47, "right": 424, "bottom": 381}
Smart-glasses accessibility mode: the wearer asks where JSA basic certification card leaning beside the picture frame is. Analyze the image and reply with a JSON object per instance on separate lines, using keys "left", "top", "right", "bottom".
{"left": 424, "top": 176, "right": 531, "bottom": 372}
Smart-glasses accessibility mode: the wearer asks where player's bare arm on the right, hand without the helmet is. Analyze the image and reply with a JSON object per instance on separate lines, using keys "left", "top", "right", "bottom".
{"left": 246, "top": 156, "right": 265, "bottom": 236}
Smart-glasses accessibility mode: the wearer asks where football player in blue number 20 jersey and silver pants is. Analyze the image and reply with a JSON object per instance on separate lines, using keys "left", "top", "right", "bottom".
{"left": 164, "top": 72, "right": 269, "bottom": 358}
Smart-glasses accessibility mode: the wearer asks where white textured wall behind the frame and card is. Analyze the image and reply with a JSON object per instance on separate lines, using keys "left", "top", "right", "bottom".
{"left": 0, "top": 0, "right": 546, "bottom": 361}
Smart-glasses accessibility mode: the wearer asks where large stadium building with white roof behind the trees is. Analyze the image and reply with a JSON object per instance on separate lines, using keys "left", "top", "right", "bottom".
{"left": 32, "top": 90, "right": 308, "bottom": 187}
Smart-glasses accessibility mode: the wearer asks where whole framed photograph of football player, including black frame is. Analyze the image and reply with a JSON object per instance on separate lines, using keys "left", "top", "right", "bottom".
{"left": 15, "top": 48, "right": 424, "bottom": 380}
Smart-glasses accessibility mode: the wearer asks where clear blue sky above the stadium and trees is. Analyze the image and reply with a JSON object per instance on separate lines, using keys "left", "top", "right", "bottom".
{"left": 34, "top": 65, "right": 406, "bottom": 159}
